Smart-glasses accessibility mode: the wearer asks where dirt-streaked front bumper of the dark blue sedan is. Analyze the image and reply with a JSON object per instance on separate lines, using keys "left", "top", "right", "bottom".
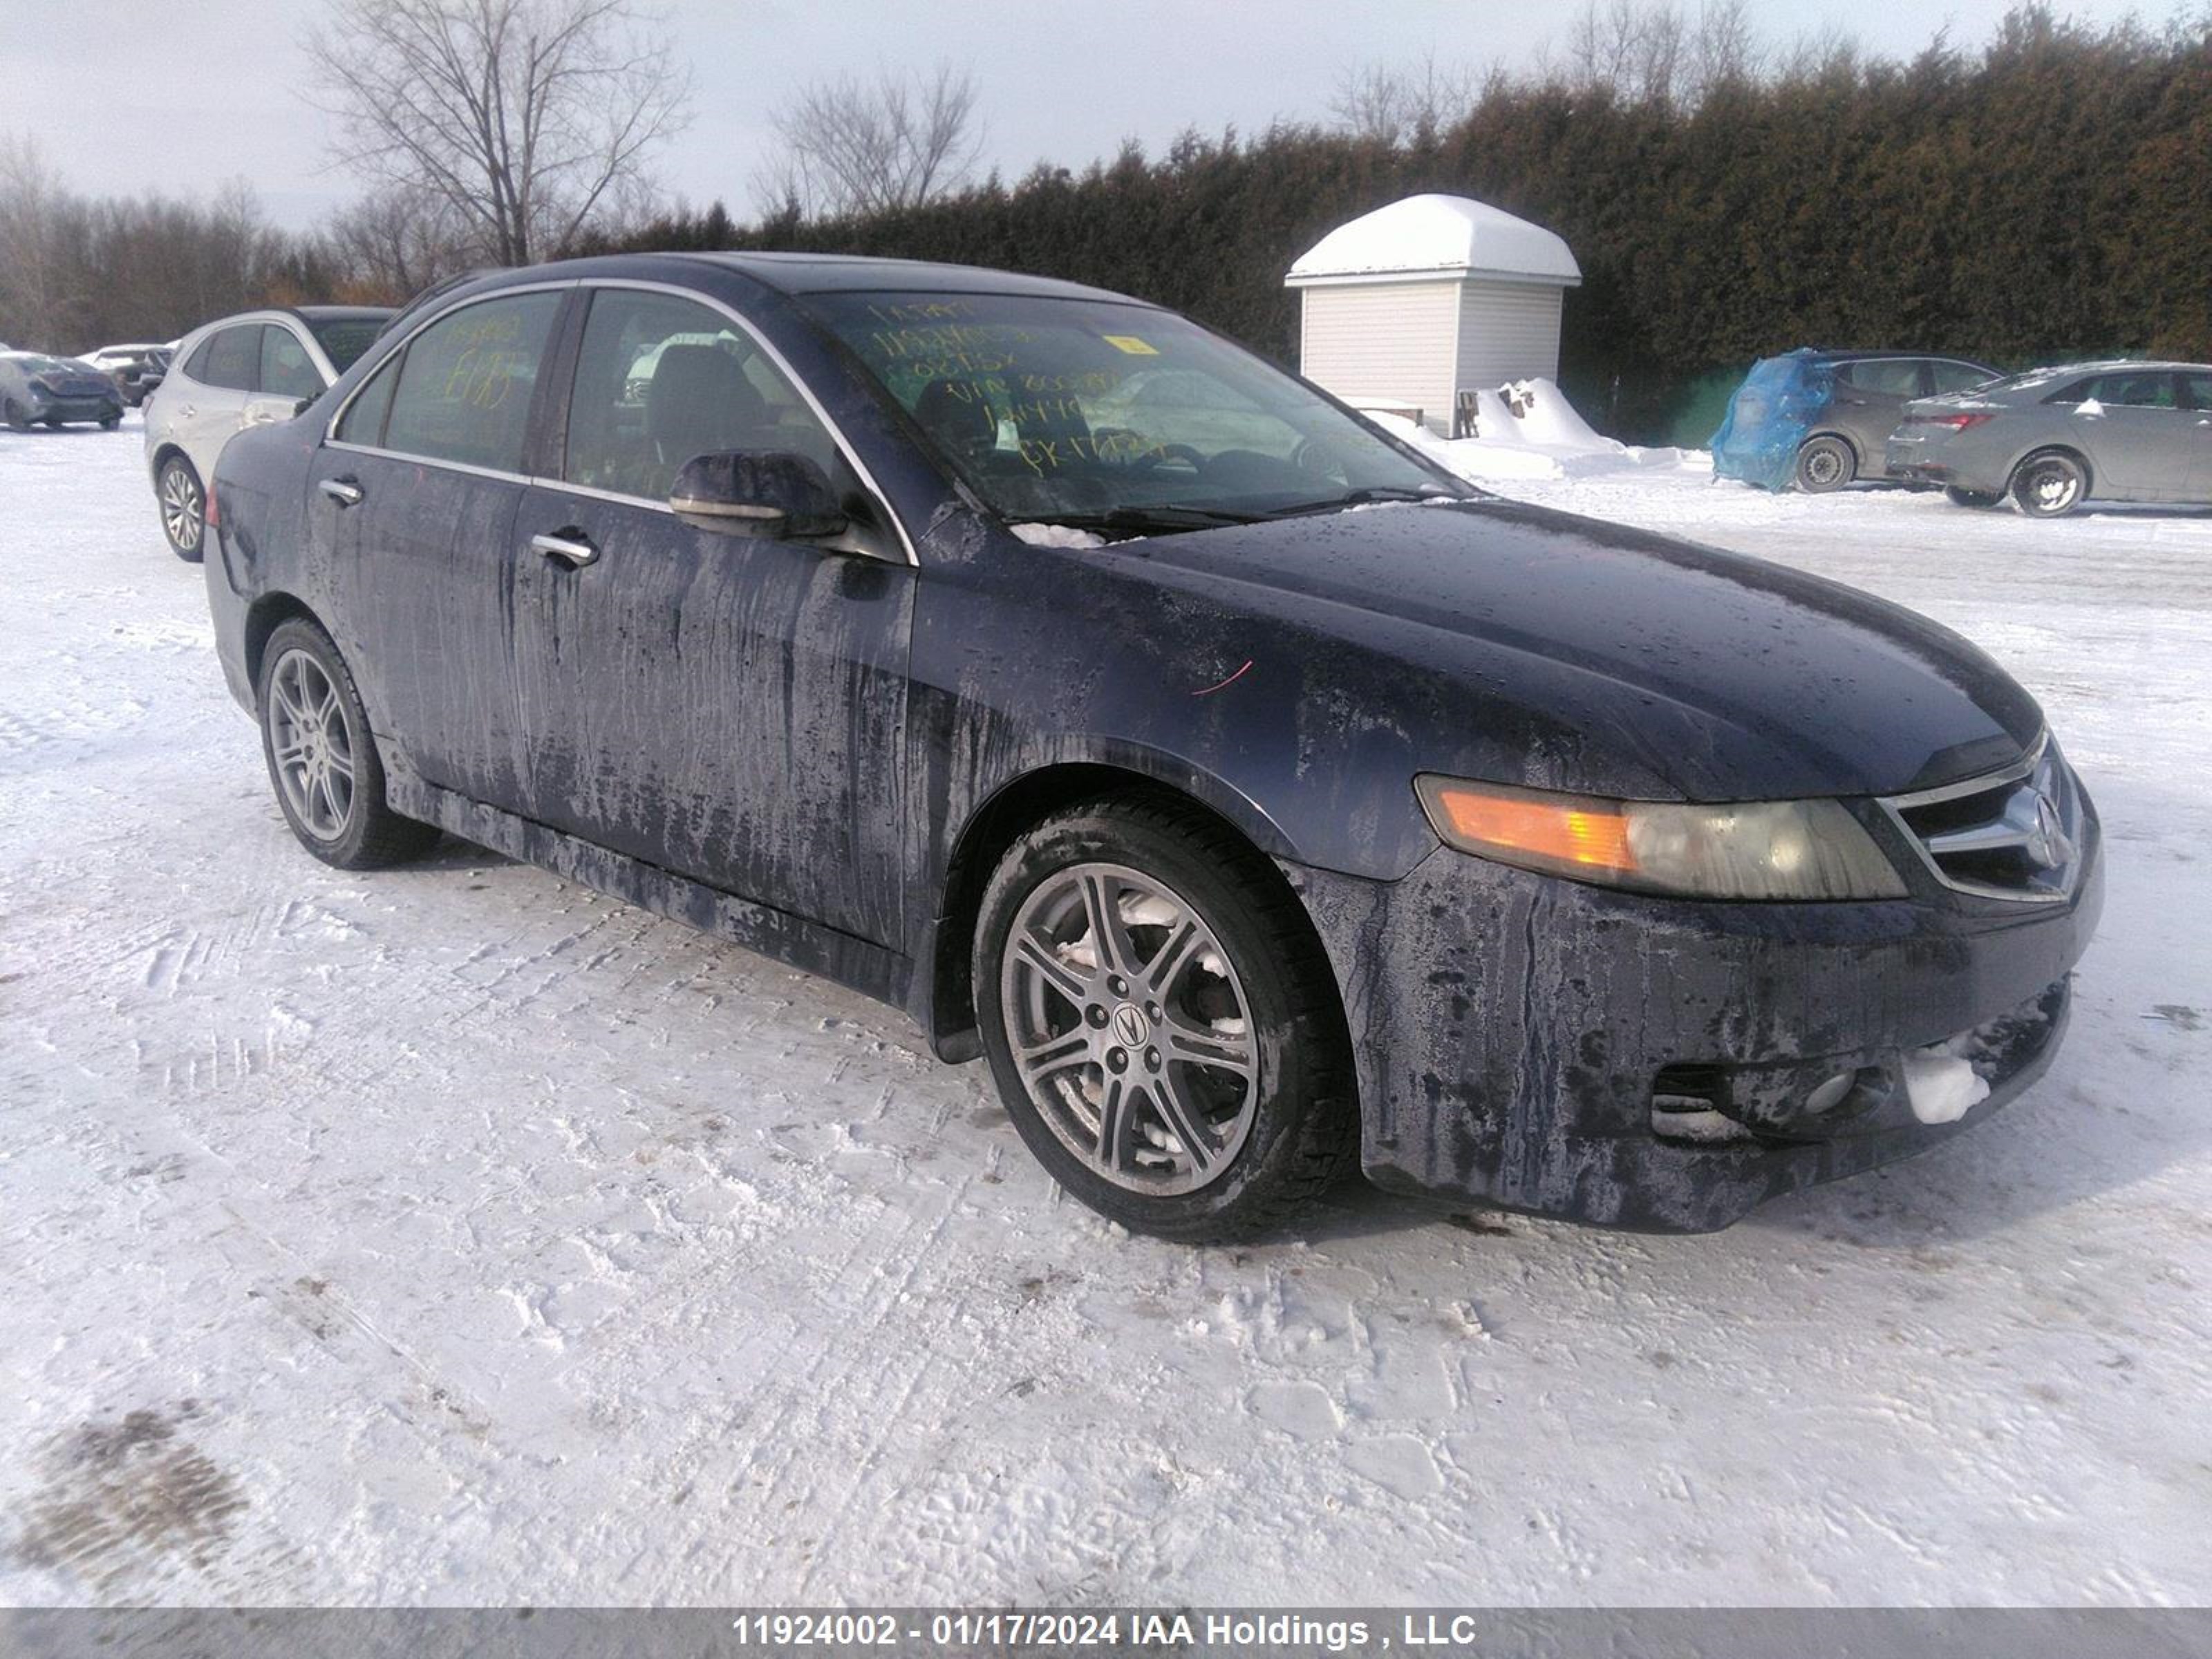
{"left": 1285, "top": 814, "right": 2103, "bottom": 1232}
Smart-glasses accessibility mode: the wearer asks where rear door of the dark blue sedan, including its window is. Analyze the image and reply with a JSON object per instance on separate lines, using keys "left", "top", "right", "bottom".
{"left": 308, "top": 285, "right": 568, "bottom": 812}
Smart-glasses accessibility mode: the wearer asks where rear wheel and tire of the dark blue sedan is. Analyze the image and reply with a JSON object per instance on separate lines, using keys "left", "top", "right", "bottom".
{"left": 254, "top": 617, "right": 438, "bottom": 870}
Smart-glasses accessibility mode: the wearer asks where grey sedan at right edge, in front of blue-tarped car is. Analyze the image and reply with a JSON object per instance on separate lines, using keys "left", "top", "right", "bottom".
{"left": 1889, "top": 363, "right": 2212, "bottom": 518}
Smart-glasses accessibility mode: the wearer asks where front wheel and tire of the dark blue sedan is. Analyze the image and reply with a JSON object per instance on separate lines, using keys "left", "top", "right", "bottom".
{"left": 973, "top": 794, "right": 1358, "bottom": 1243}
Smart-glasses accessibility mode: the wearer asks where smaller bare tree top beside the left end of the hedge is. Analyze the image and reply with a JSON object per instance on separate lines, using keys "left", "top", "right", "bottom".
{"left": 754, "top": 62, "right": 982, "bottom": 219}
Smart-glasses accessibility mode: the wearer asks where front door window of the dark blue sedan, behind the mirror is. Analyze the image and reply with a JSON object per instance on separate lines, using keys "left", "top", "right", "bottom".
{"left": 562, "top": 288, "right": 838, "bottom": 500}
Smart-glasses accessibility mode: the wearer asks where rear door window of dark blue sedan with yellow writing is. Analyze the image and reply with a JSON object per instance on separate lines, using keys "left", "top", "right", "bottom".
{"left": 383, "top": 294, "right": 562, "bottom": 474}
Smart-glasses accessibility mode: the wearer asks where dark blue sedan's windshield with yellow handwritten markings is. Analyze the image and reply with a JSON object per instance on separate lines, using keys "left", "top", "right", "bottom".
{"left": 809, "top": 292, "right": 1471, "bottom": 531}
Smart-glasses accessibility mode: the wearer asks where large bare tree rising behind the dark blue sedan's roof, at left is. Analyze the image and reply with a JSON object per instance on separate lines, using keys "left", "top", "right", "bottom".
{"left": 306, "top": 0, "right": 690, "bottom": 265}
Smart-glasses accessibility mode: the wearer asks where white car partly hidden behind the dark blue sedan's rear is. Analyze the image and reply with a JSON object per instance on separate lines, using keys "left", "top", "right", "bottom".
{"left": 146, "top": 306, "right": 391, "bottom": 560}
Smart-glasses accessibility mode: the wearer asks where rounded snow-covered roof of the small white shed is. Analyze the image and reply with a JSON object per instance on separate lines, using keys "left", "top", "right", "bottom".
{"left": 1283, "top": 195, "right": 1582, "bottom": 288}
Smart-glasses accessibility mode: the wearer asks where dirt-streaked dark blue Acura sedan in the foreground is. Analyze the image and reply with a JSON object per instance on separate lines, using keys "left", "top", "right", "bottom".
{"left": 206, "top": 254, "right": 2101, "bottom": 1239}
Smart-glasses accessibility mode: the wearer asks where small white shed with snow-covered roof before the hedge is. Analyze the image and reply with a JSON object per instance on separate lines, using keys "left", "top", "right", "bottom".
{"left": 1283, "top": 195, "right": 1582, "bottom": 433}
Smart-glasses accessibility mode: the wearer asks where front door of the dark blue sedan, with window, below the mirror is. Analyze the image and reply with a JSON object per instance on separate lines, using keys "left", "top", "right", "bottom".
{"left": 513, "top": 288, "right": 916, "bottom": 947}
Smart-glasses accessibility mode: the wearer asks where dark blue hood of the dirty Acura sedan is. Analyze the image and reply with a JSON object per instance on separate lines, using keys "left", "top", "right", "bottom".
{"left": 1110, "top": 500, "right": 2042, "bottom": 800}
